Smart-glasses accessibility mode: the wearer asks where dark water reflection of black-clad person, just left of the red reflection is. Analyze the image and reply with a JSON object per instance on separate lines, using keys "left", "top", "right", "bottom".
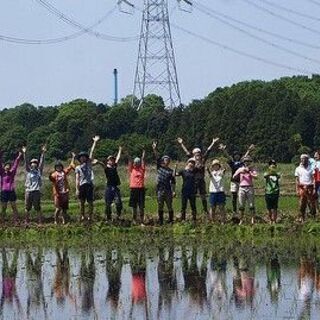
{"left": 106, "top": 250, "right": 122, "bottom": 310}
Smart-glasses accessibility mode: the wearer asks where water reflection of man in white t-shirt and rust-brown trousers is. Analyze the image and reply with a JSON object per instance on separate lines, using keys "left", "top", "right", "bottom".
{"left": 299, "top": 257, "right": 316, "bottom": 319}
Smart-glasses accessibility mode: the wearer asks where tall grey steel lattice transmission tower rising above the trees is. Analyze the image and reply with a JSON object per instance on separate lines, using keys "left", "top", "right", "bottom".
{"left": 133, "top": 0, "right": 191, "bottom": 108}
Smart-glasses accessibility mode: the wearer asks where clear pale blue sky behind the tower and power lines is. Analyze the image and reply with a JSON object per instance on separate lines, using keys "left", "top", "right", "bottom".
{"left": 0, "top": 0, "right": 320, "bottom": 108}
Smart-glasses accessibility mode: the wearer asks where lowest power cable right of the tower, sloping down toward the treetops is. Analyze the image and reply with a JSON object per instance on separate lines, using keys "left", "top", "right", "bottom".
{"left": 171, "top": 23, "right": 315, "bottom": 75}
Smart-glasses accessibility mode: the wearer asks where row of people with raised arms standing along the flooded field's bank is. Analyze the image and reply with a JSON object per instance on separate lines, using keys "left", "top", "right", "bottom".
{"left": 0, "top": 136, "right": 320, "bottom": 225}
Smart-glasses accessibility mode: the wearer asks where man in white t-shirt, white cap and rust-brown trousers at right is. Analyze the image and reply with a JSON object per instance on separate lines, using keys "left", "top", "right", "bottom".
{"left": 294, "top": 154, "right": 316, "bottom": 222}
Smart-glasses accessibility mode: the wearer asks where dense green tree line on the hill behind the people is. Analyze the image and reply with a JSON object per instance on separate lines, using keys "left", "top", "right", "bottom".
{"left": 0, "top": 75, "right": 320, "bottom": 162}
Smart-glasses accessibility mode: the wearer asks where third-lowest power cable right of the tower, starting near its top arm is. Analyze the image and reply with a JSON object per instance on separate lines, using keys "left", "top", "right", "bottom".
{"left": 193, "top": 3, "right": 320, "bottom": 49}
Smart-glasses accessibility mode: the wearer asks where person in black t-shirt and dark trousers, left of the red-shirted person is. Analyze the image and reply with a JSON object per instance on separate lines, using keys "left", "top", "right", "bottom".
{"left": 97, "top": 146, "right": 123, "bottom": 222}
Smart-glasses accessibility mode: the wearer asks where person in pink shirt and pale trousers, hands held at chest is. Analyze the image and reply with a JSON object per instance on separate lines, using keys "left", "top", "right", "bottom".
{"left": 233, "top": 156, "right": 258, "bottom": 224}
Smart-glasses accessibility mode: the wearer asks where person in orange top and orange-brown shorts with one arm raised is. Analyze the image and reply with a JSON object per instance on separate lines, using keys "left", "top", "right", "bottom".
{"left": 49, "top": 152, "right": 76, "bottom": 224}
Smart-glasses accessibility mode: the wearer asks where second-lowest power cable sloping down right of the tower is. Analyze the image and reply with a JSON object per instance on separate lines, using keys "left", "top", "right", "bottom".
{"left": 195, "top": 5, "right": 320, "bottom": 64}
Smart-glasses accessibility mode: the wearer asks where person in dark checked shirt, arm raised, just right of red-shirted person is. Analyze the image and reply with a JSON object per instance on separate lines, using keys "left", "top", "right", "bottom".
{"left": 152, "top": 141, "right": 176, "bottom": 225}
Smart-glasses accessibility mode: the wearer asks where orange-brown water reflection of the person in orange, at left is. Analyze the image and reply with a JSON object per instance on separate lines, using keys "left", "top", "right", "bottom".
{"left": 53, "top": 248, "right": 73, "bottom": 305}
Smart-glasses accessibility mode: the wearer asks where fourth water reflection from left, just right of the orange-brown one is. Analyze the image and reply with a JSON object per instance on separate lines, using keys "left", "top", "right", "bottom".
{"left": 80, "top": 252, "right": 96, "bottom": 313}
